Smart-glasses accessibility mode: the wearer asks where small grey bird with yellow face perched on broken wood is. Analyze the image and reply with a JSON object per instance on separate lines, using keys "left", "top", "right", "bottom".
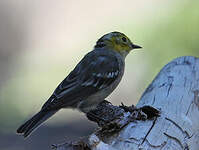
{"left": 17, "top": 31, "right": 142, "bottom": 138}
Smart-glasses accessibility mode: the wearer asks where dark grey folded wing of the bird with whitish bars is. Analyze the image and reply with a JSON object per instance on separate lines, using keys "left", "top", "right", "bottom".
{"left": 42, "top": 53, "right": 120, "bottom": 109}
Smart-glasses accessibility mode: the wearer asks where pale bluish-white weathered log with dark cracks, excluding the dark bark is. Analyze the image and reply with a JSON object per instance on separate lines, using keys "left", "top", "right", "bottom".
{"left": 54, "top": 56, "right": 199, "bottom": 150}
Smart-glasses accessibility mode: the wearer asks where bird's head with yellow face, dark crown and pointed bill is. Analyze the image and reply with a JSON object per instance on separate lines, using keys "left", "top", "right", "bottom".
{"left": 95, "top": 32, "right": 142, "bottom": 56}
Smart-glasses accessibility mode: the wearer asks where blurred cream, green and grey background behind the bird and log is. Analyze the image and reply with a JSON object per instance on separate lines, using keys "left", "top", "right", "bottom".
{"left": 0, "top": 0, "right": 199, "bottom": 150}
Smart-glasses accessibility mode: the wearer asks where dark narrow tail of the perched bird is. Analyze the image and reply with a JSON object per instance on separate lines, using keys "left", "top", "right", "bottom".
{"left": 17, "top": 110, "right": 57, "bottom": 137}
